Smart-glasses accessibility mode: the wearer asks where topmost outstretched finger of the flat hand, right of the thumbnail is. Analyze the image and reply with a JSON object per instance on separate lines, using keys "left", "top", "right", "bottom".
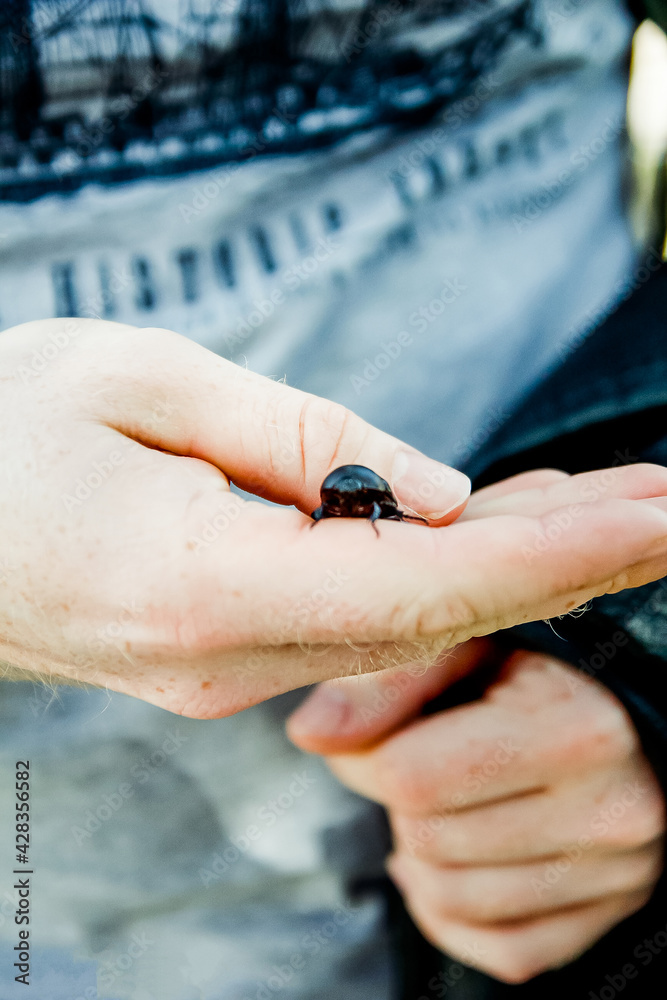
{"left": 465, "top": 463, "right": 667, "bottom": 520}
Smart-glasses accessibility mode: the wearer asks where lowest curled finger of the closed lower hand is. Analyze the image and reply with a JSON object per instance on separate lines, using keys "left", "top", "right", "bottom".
{"left": 396, "top": 890, "right": 650, "bottom": 984}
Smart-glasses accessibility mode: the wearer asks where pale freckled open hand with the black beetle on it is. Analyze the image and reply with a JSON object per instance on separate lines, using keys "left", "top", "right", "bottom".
{"left": 0, "top": 320, "right": 667, "bottom": 718}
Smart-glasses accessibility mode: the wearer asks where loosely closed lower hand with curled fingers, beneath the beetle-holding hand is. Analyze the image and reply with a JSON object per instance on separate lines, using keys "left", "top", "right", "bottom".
{"left": 288, "top": 640, "right": 665, "bottom": 983}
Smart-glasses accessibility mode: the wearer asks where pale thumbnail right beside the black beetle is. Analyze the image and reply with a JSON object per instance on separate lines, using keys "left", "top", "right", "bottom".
{"left": 391, "top": 450, "right": 470, "bottom": 520}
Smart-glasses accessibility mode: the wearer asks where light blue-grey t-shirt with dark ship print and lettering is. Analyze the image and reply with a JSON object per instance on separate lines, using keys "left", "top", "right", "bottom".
{"left": 0, "top": 0, "right": 635, "bottom": 1000}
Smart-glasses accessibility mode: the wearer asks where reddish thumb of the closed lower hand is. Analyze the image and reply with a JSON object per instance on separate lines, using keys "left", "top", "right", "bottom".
{"left": 287, "top": 639, "right": 493, "bottom": 756}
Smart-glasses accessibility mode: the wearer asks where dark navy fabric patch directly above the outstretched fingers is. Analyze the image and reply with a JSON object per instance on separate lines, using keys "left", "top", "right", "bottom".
{"left": 466, "top": 251, "right": 667, "bottom": 488}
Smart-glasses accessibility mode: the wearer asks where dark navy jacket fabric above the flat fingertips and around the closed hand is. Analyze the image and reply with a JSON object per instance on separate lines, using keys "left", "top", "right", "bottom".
{"left": 404, "top": 266, "right": 667, "bottom": 1000}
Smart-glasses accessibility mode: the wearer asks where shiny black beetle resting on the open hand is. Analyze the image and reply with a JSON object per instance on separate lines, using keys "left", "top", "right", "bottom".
{"left": 311, "top": 465, "right": 428, "bottom": 536}
